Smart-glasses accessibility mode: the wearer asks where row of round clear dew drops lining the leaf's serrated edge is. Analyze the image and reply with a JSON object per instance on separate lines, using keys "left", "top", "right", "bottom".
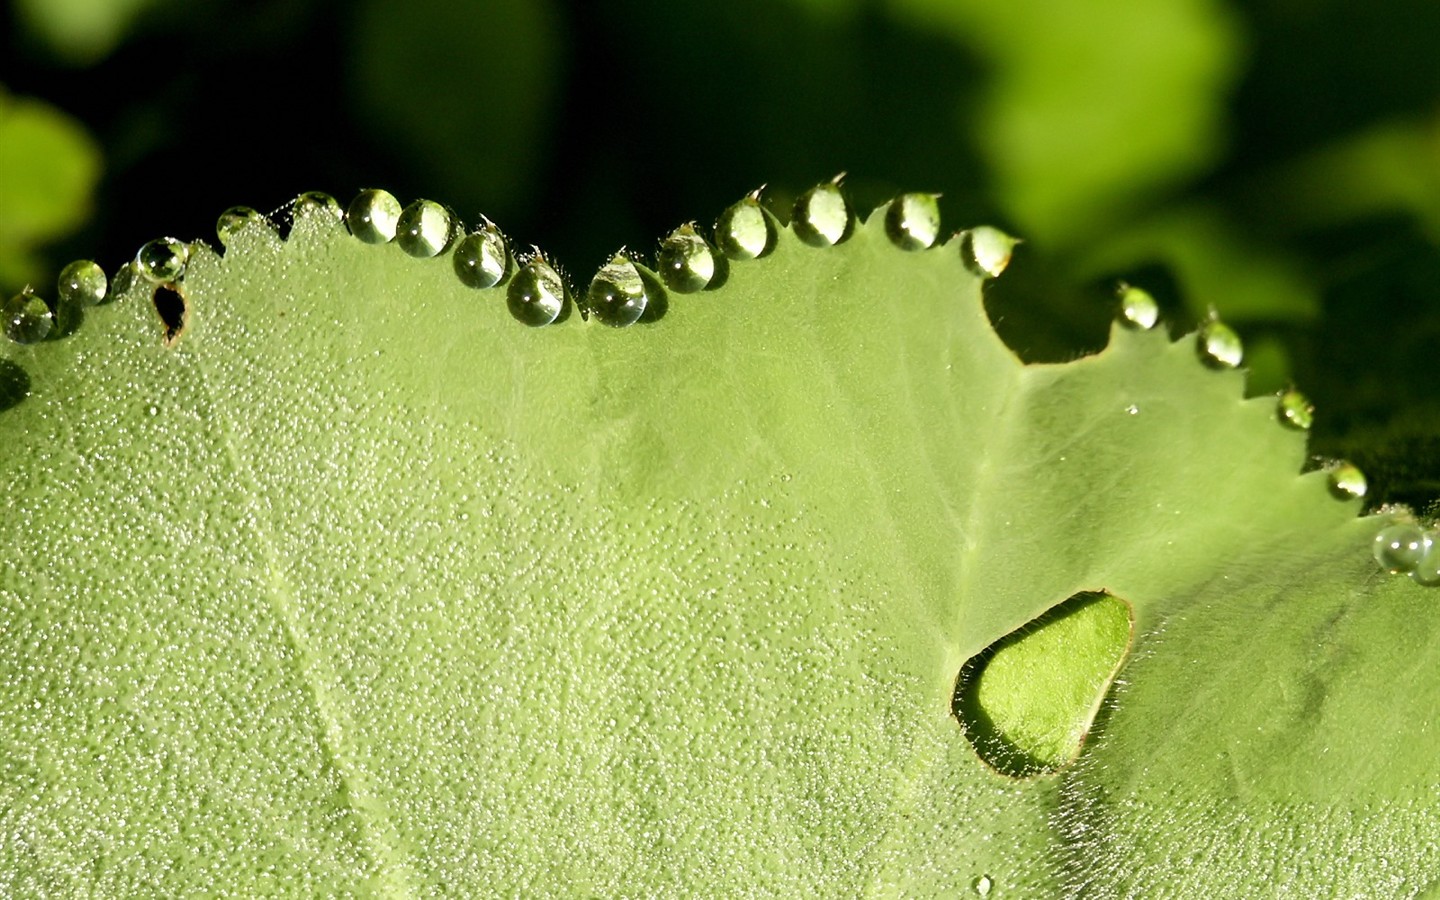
{"left": 0, "top": 176, "right": 1405, "bottom": 585}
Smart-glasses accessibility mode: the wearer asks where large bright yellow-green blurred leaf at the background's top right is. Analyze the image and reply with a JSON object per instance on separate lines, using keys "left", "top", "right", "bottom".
{"left": 890, "top": 0, "right": 1240, "bottom": 246}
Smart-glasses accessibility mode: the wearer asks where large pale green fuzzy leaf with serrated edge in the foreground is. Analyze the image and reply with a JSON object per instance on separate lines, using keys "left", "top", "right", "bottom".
{"left": 0, "top": 192, "right": 1440, "bottom": 897}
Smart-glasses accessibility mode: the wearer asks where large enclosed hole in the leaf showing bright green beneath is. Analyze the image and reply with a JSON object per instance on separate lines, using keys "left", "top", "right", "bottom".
{"left": 955, "top": 593, "right": 1130, "bottom": 778}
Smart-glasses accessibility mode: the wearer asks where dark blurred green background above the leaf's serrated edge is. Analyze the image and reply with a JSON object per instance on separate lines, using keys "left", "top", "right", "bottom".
{"left": 8, "top": 0, "right": 1440, "bottom": 505}
